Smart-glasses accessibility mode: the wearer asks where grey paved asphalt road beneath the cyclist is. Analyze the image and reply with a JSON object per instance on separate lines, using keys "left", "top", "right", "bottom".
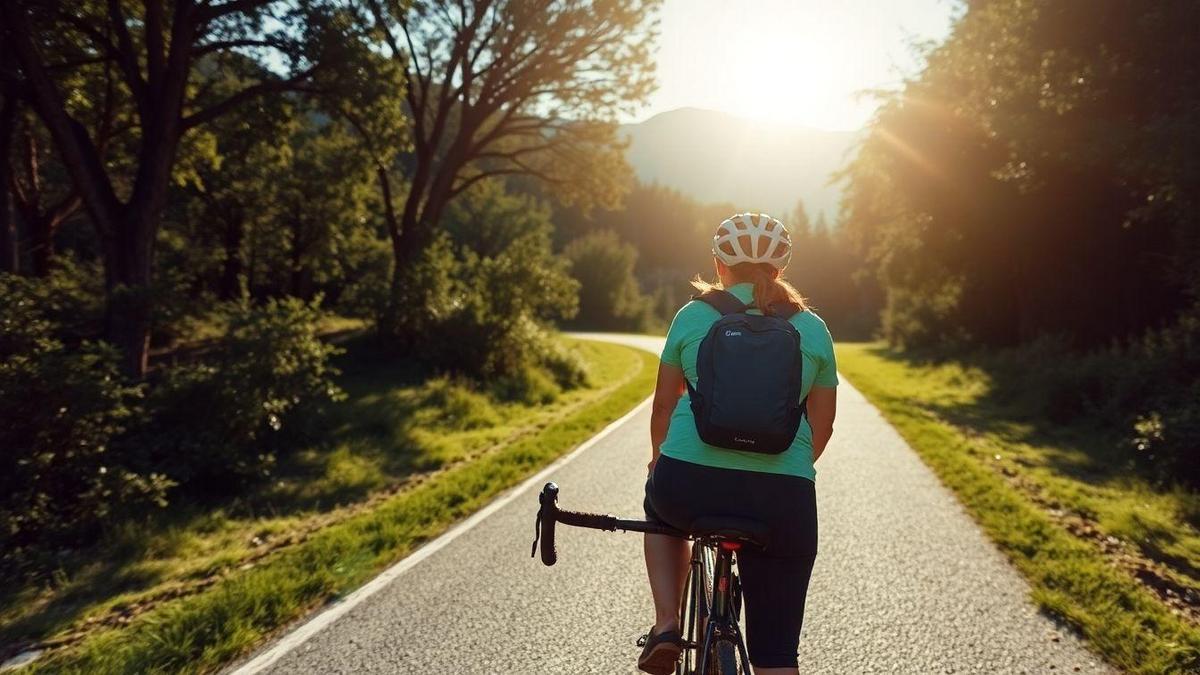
{"left": 236, "top": 336, "right": 1109, "bottom": 675}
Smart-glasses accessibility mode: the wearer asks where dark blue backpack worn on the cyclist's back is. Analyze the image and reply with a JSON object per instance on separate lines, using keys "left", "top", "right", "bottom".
{"left": 688, "top": 291, "right": 808, "bottom": 454}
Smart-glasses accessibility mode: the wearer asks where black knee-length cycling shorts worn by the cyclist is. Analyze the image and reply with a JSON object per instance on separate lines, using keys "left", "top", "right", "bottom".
{"left": 644, "top": 456, "right": 817, "bottom": 668}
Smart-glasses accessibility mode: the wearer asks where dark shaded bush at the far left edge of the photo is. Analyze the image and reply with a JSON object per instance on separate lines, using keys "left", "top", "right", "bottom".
{"left": 0, "top": 270, "right": 170, "bottom": 568}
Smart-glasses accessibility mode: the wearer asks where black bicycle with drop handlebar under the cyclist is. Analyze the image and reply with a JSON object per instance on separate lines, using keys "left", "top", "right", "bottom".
{"left": 529, "top": 483, "right": 768, "bottom": 675}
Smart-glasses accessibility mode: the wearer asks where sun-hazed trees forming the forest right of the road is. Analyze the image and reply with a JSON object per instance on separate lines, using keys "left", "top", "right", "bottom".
{"left": 838, "top": 1, "right": 1200, "bottom": 488}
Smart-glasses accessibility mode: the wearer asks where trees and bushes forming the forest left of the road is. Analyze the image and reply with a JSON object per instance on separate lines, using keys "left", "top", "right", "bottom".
{"left": 0, "top": 0, "right": 654, "bottom": 577}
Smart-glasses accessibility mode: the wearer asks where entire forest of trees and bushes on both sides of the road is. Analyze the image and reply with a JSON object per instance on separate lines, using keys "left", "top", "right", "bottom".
{"left": 0, "top": 0, "right": 1200, "bottom": 653}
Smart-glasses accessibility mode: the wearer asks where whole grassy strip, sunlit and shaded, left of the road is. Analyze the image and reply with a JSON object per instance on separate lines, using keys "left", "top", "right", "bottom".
{"left": 0, "top": 341, "right": 655, "bottom": 673}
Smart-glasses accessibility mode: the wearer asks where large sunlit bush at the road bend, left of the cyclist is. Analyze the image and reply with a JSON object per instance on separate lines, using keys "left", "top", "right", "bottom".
{"left": 388, "top": 184, "right": 584, "bottom": 401}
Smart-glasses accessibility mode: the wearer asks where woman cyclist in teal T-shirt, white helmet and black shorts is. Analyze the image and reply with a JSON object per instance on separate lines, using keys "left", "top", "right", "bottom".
{"left": 637, "top": 214, "right": 838, "bottom": 675}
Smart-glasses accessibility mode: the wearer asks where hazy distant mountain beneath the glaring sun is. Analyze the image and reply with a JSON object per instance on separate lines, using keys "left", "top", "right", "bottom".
{"left": 622, "top": 108, "right": 862, "bottom": 223}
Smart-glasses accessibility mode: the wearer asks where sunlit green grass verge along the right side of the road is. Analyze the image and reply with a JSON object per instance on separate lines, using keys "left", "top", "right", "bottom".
{"left": 838, "top": 344, "right": 1200, "bottom": 673}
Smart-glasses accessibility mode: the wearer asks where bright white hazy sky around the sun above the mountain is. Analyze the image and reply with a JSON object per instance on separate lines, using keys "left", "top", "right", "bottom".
{"left": 637, "top": 0, "right": 959, "bottom": 130}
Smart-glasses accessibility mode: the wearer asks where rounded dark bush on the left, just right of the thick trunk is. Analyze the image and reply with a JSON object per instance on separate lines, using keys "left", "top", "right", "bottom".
{"left": 137, "top": 298, "right": 343, "bottom": 492}
